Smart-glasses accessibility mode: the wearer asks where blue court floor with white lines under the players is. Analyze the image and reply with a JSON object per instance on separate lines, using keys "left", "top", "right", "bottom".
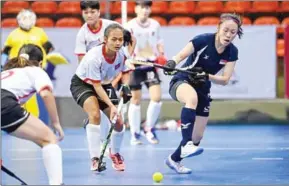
{"left": 2, "top": 125, "right": 289, "bottom": 185}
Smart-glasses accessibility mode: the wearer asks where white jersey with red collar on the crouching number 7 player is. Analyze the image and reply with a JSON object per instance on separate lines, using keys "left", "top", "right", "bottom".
{"left": 76, "top": 45, "right": 129, "bottom": 84}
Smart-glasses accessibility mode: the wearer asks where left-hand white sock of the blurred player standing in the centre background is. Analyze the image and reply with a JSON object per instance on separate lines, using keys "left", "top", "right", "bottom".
{"left": 128, "top": 103, "right": 141, "bottom": 134}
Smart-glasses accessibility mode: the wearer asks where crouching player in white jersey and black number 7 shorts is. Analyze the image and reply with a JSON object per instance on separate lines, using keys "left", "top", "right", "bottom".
{"left": 70, "top": 24, "right": 129, "bottom": 171}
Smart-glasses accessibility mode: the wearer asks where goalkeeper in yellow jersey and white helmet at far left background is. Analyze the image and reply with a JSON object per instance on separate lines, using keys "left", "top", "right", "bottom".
{"left": 2, "top": 9, "right": 68, "bottom": 124}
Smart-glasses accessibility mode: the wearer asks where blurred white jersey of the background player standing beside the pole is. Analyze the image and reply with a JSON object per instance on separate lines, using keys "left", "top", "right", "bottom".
{"left": 125, "top": 18, "right": 163, "bottom": 61}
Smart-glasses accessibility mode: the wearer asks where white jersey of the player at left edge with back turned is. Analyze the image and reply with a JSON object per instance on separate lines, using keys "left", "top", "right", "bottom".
{"left": 1, "top": 66, "right": 53, "bottom": 104}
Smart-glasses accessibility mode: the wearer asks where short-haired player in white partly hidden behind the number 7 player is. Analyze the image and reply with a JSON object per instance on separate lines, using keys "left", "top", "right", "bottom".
{"left": 74, "top": 1, "right": 135, "bottom": 62}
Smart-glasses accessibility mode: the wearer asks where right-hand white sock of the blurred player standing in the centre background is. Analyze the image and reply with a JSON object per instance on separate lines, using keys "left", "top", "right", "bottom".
{"left": 146, "top": 101, "right": 162, "bottom": 128}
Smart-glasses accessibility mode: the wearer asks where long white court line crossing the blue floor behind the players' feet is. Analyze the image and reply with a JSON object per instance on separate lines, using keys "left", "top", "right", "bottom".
{"left": 9, "top": 146, "right": 289, "bottom": 152}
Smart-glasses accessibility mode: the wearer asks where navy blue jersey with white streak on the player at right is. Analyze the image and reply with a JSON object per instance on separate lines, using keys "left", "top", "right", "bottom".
{"left": 173, "top": 33, "right": 238, "bottom": 85}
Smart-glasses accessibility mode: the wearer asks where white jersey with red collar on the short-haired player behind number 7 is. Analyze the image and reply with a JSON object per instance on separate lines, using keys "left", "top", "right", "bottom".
{"left": 74, "top": 19, "right": 119, "bottom": 56}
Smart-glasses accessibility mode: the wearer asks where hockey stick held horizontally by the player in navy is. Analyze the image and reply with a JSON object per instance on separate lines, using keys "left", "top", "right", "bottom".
{"left": 126, "top": 59, "right": 202, "bottom": 76}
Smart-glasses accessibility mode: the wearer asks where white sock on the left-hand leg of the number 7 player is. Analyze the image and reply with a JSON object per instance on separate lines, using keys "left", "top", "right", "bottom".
{"left": 86, "top": 124, "right": 101, "bottom": 159}
